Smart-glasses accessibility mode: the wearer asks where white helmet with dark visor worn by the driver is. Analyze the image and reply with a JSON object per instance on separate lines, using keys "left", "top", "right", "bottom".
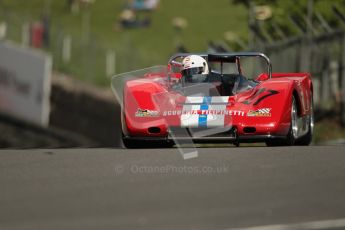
{"left": 181, "top": 55, "right": 209, "bottom": 76}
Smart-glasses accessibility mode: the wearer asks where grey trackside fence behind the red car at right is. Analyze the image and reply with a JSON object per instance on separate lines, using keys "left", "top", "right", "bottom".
{"left": 260, "top": 30, "right": 345, "bottom": 125}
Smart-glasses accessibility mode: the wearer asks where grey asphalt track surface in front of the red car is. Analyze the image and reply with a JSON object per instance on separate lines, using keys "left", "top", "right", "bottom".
{"left": 0, "top": 146, "right": 345, "bottom": 230}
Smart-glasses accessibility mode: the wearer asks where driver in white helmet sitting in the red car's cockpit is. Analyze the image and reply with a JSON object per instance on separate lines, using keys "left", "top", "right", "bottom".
{"left": 181, "top": 55, "right": 209, "bottom": 83}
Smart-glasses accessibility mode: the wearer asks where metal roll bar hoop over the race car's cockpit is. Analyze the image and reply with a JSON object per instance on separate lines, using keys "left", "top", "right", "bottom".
{"left": 169, "top": 52, "right": 272, "bottom": 78}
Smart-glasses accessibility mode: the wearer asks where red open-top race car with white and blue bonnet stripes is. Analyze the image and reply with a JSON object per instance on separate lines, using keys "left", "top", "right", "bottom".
{"left": 112, "top": 52, "right": 314, "bottom": 148}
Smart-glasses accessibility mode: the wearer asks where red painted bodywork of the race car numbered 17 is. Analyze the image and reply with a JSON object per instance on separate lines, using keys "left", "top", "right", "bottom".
{"left": 122, "top": 54, "right": 313, "bottom": 142}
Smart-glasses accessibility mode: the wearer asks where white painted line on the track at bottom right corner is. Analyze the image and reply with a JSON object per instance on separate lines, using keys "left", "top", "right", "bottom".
{"left": 226, "top": 219, "right": 345, "bottom": 230}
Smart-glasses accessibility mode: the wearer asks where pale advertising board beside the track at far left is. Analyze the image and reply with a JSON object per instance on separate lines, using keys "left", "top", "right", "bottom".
{"left": 0, "top": 41, "right": 52, "bottom": 126}
